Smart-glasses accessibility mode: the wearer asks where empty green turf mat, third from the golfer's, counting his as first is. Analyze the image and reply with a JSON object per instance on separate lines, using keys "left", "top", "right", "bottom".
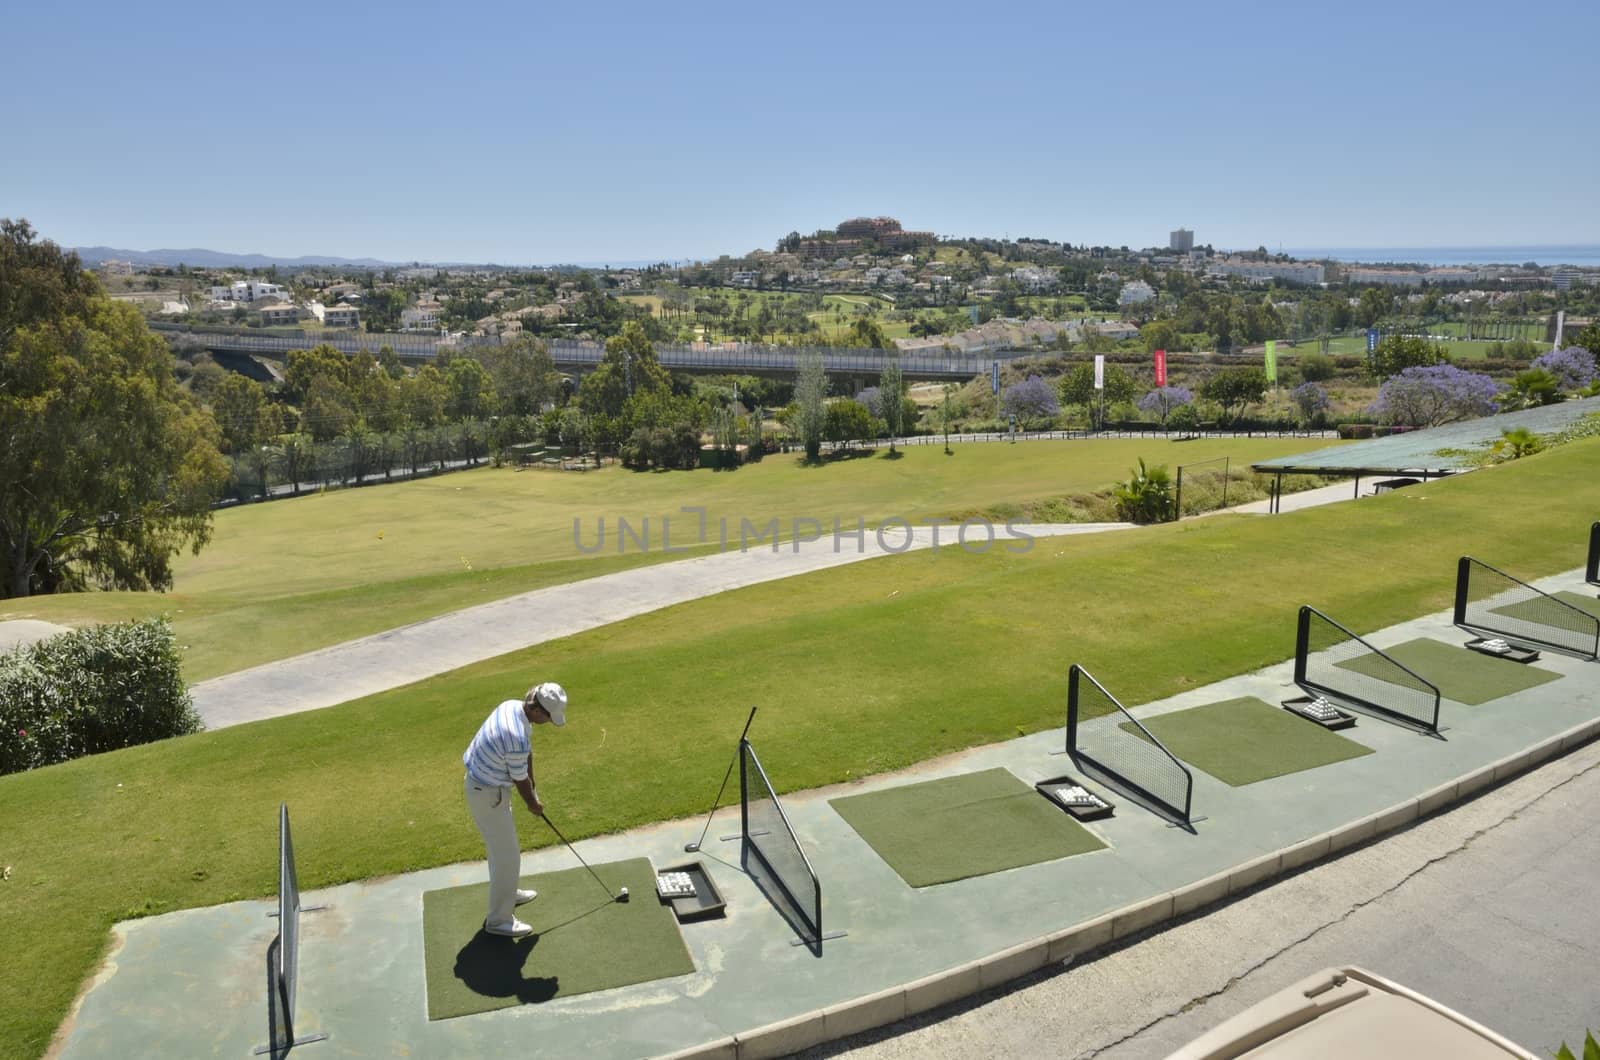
{"left": 1122, "top": 697, "right": 1373, "bottom": 788}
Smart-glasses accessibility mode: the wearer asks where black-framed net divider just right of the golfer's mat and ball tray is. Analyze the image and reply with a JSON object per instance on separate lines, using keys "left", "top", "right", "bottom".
{"left": 739, "top": 738, "right": 845, "bottom": 954}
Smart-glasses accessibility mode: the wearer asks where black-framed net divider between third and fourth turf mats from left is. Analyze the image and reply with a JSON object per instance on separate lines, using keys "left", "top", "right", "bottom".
{"left": 1294, "top": 607, "right": 1440, "bottom": 737}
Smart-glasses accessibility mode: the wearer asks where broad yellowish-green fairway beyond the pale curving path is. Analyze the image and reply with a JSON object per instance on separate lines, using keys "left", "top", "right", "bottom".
{"left": 0, "top": 439, "right": 1323, "bottom": 681}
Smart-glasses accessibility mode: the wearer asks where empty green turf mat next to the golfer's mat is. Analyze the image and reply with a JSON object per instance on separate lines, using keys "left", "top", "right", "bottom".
{"left": 829, "top": 769, "right": 1106, "bottom": 887}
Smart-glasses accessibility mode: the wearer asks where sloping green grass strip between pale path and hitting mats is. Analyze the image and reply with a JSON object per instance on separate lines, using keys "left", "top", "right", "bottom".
{"left": 0, "top": 439, "right": 1600, "bottom": 1057}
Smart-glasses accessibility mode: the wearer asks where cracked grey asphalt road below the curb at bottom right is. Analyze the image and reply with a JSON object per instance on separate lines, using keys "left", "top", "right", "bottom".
{"left": 800, "top": 745, "right": 1600, "bottom": 1060}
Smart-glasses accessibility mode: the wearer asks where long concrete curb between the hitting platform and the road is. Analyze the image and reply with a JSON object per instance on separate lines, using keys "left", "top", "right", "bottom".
{"left": 662, "top": 717, "right": 1600, "bottom": 1060}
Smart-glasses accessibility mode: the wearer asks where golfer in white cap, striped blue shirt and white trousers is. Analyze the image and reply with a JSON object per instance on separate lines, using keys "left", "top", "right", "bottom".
{"left": 461, "top": 681, "right": 566, "bottom": 938}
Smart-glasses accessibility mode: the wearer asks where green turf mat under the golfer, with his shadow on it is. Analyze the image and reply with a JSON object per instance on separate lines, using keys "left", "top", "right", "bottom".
{"left": 422, "top": 858, "right": 694, "bottom": 1020}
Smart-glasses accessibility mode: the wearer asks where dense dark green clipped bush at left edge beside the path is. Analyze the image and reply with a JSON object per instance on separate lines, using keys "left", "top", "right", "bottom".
{"left": 0, "top": 618, "right": 202, "bottom": 773}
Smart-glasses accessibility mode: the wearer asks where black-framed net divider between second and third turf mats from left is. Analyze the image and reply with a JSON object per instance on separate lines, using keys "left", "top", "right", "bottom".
{"left": 1067, "top": 663, "right": 1195, "bottom": 831}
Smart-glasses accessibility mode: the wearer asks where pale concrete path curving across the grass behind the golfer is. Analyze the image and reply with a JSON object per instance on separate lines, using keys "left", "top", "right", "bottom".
{"left": 192, "top": 522, "right": 1131, "bottom": 729}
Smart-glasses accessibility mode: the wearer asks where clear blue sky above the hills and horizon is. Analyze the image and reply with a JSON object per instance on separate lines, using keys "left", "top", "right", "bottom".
{"left": 0, "top": 0, "right": 1600, "bottom": 263}
